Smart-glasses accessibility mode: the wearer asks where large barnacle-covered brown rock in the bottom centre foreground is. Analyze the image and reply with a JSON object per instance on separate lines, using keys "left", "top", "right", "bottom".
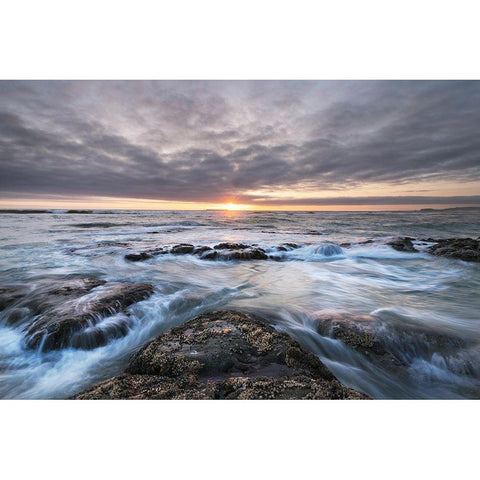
{"left": 74, "top": 311, "right": 367, "bottom": 399}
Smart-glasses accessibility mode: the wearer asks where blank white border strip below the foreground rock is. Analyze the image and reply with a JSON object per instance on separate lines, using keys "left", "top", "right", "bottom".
{"left": 0, "top": 400, "right": 480, "bottom": 480}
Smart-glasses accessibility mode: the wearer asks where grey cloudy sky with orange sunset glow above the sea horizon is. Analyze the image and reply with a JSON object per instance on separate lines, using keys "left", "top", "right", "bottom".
{"left": 0, "top": 80, "right": 480, "bottom": 210}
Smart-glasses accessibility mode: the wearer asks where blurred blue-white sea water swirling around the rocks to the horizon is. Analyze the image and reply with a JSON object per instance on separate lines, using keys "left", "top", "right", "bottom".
{"left": 0, "top": 211, "right": 480, "bottom": 398}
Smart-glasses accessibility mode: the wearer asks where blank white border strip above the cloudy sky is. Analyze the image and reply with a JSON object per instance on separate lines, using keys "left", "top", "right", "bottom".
{"left": 0, "top": 0, "right": 480, "bottom": 79}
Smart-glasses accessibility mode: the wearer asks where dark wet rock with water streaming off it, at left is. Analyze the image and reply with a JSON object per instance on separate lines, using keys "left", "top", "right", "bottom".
{"left": 19, "top": 279, "right": 153, "bottom": 351}
